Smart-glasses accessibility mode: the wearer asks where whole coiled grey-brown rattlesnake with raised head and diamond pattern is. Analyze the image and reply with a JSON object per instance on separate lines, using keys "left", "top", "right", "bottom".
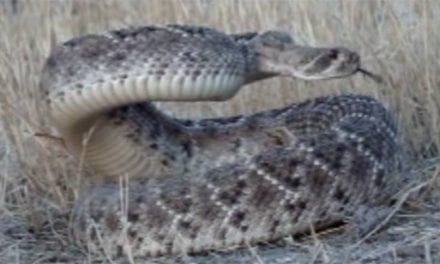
{"left": 41, "top": 25, "right": 401, "bottom": 256}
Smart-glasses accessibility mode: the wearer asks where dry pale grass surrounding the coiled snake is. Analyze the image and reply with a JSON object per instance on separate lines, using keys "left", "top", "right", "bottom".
{"left": 0, "top": 0, "right": 440, "bottom": 263}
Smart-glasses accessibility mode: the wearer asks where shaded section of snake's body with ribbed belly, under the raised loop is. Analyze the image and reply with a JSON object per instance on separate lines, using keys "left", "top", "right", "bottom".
{"left": 63, "top": 103, "right": 196, "bottom": 181}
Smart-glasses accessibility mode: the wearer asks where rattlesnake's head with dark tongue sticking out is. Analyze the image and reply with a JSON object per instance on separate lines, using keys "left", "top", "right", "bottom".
{"left": 255, "top": 31, "right": 380, "bottom": 80}
